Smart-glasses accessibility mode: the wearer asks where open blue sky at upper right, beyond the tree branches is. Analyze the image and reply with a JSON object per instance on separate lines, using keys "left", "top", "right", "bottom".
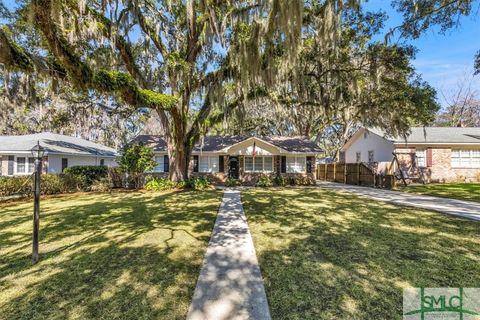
{"left": 364, "top": 0, "right": 480, "bottom": 105}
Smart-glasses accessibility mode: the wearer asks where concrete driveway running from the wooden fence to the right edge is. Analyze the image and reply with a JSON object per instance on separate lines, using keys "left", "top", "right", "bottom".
{"left": 317, "top": 181, "right": 480, "bottom": 221}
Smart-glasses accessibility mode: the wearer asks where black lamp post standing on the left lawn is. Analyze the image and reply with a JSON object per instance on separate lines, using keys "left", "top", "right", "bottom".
{"left": 31, "top": 141, "right": 45, "bottom": 264}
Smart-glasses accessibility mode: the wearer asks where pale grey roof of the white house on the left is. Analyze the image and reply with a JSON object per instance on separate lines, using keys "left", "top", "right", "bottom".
{"left": 0, "top": 132, "right": 117, "bottom": 157}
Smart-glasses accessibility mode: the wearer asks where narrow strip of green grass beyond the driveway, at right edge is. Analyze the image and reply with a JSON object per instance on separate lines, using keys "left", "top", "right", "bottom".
{"left": 399, "top": 183, "right": 480, "bottom": 202}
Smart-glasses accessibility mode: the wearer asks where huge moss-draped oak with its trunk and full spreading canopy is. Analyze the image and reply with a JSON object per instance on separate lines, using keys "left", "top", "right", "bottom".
{"left": 0, "top": 0, "right": 437, "bottom": 180}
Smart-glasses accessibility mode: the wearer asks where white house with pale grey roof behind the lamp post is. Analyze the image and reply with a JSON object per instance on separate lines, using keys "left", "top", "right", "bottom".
{"left": 0, "top": 132, "right": 117, "bottom": 176}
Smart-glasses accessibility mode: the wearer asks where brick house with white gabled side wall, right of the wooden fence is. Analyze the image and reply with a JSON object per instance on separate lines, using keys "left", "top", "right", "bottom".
{"left": 339, "top": 127, "right": 480, "bottom": 182}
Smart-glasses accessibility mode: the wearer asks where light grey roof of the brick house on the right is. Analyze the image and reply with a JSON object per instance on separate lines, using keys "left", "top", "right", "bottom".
{"left": 368, "top": 127, "right": 480, "bottom": 144}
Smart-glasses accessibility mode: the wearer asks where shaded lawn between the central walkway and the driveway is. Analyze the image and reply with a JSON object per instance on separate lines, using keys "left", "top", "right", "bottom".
{"left": 242, "top": 188, "right": 480, "bottom": 320}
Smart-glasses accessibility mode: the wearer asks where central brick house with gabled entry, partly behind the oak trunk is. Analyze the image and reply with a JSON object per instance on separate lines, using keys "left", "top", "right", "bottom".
{"left": 133, "top": 135, "right": 321, "bottom": 183}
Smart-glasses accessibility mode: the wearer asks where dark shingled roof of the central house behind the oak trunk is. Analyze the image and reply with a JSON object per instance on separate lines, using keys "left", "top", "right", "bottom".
{"left": 132, "top": 135, "right": 322, "bottom": 153}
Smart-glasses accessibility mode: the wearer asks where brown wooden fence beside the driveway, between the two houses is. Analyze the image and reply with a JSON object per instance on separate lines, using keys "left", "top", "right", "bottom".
{"left": 316, "top": 163, "right": 395, "bottom": 189}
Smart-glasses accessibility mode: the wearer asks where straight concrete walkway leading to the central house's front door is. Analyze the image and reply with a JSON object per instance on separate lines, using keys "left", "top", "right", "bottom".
{"left": 187, "top": 189, "right": 270, "bottom": 320}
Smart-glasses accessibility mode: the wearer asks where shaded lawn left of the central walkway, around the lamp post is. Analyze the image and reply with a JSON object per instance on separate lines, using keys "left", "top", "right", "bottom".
{"left": 0, "top": 191, "right": 221, "bottom": 319}
